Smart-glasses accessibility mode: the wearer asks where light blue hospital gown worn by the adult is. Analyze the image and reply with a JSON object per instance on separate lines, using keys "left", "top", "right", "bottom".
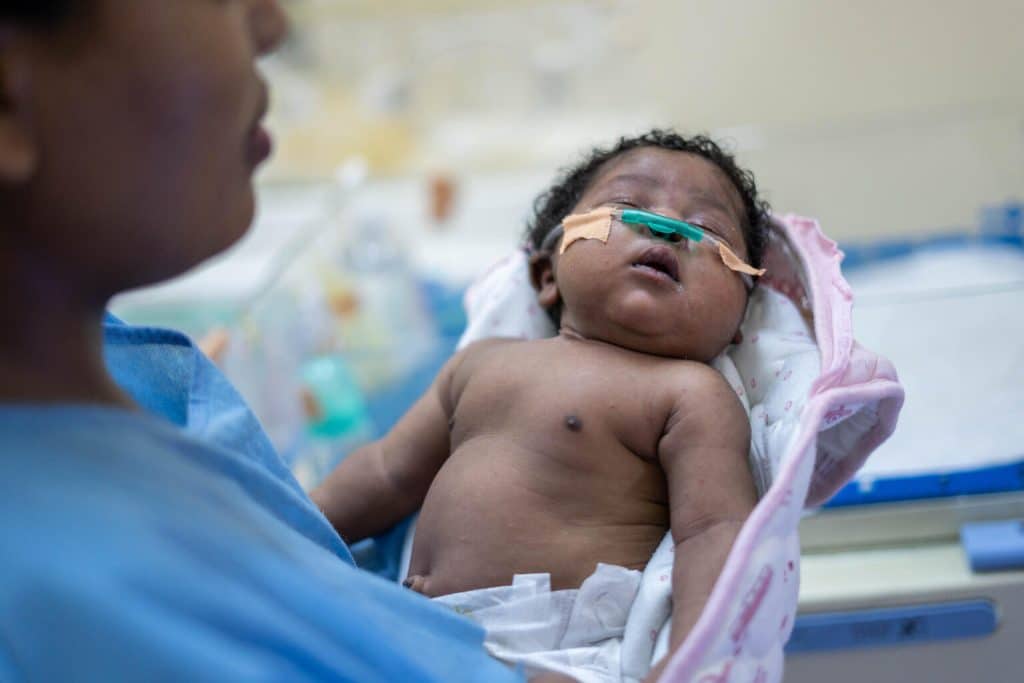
{"left": 0, "top": 319, "right": 522, "bottom": 682}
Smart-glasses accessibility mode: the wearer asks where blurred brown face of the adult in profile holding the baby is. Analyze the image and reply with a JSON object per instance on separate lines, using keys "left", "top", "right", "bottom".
{"left": 0, "top": 0, "right": 286, "bottom": 294}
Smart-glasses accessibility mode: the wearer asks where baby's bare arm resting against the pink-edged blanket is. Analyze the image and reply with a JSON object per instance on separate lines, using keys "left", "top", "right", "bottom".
{"left": 648, "top": 367, "right": 757, "bottom": 680}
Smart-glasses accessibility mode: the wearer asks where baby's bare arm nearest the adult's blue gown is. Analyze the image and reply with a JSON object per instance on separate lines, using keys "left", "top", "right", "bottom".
{"left": 310, "top": 352, "right": 464, "bottom": 543}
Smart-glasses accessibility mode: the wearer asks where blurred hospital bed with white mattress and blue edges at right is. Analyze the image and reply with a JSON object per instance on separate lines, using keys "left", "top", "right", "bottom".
{"left": 785, "top": 227, "right": 1024, "bottom": 683}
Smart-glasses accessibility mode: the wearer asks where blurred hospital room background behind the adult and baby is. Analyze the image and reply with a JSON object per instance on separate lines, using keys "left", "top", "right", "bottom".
{"left": 112, "top": 0, "right": 1024, "bottom": 683}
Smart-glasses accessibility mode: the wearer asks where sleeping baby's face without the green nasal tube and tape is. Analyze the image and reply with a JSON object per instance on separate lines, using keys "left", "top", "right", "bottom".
{"left": 554, "top": 147, "right": 749, "bottom": 362}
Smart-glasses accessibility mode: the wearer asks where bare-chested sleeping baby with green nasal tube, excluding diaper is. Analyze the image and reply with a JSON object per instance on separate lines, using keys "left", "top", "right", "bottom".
{"left": 313, "top": 130, "right": 768, "bottom": 680}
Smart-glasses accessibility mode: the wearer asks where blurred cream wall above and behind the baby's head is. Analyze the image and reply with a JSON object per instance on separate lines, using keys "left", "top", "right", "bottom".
{"left": 292, "top": 0, "right": 1024, "bottom": 241}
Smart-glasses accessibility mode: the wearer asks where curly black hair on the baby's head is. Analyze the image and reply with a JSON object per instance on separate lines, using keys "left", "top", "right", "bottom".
{"left": 526, "top": 128, "right": 771, "bottom": 268}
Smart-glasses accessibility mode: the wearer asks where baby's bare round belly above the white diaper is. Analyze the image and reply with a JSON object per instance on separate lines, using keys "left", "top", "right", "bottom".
{"left": 410, "top": 439, "right": 668, "bottom": 596}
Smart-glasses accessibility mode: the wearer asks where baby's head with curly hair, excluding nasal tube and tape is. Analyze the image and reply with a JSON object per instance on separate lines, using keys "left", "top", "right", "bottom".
{"left": 527, "top": 130, "right": 769, "bottom": 361}
